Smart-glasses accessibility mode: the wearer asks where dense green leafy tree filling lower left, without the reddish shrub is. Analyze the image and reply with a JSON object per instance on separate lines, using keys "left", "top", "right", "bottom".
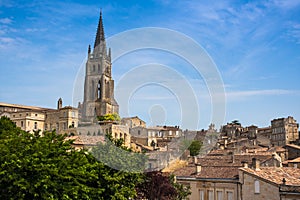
{"left": 0, "top": 117, "right": 142, "bottom": 200}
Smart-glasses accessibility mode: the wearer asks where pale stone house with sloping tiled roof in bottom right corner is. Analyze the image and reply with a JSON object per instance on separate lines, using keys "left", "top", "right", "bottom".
{"left": 239, "top": 165, "right": 300, "bottom": 200}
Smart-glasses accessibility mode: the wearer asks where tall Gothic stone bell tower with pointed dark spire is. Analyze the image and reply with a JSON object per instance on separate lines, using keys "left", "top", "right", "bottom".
{"left": 79, "top": 12, "right": 119, "bottom": 122}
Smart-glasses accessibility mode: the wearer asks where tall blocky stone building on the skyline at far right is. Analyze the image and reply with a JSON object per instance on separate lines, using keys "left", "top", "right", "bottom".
{"left": 271, "top": 116, "right": 299, "bottom": 146}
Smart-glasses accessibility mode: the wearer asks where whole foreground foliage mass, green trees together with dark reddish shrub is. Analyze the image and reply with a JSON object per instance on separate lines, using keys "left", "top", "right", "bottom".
{"left": 0, "top": 117, "right": 189, "bottom": 200}
